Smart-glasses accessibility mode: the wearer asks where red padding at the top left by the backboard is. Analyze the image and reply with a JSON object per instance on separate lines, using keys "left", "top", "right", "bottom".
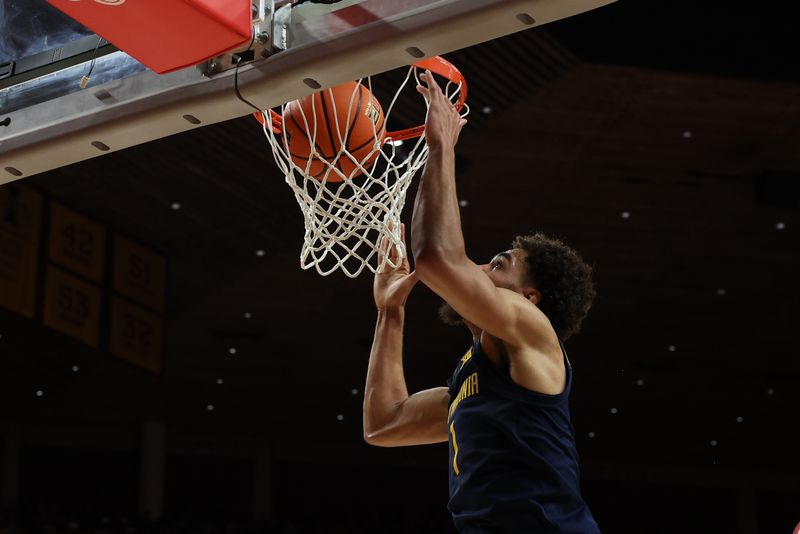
{"left": 47, "top": 0, "right": 252, "bottom": 74}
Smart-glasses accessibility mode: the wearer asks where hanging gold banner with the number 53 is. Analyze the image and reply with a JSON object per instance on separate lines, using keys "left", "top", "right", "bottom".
{"left": 42, "top": 266, "right": 102, "bottom": 347}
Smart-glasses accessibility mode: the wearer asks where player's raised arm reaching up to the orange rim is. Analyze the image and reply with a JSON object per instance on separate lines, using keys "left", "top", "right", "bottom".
{"left": 411, "top": 71, "right": 550, "bottom": 346}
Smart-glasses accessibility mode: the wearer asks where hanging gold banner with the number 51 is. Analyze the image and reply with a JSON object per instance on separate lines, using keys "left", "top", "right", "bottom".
{"left": 114, "top": 235, "right": 167, "bottom": 310}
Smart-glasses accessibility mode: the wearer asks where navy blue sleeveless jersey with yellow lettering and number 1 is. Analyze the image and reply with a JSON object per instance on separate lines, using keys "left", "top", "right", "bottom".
{"left": 447, "top": 341, "right": 600, "bottom": 534}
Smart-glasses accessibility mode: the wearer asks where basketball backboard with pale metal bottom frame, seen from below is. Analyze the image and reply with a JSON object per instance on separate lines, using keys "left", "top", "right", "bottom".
{"left": 0, "top": 0, "right": 614, "bottom": 184}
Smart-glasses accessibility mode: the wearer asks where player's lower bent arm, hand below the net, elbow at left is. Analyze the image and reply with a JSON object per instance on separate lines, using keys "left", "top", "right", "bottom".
{"left": 364, "top": 228, "right": 450, "bottom": 447}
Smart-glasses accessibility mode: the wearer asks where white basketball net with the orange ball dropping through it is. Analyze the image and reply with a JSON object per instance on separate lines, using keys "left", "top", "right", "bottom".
{"left": 262, "top": 62, "right": 467, "bottom": 278}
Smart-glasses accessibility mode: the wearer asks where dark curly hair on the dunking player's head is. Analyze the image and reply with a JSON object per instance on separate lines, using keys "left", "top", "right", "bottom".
{"left": 511, "top": 232, "right": 596, "bottom": 341}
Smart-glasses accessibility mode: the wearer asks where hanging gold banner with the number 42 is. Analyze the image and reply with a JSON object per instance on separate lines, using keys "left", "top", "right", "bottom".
{"left": 48, "top": 202, "right": 106, "bottom": 283}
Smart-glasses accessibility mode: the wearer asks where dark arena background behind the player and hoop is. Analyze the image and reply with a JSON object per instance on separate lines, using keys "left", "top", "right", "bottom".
{"left": 0, "top": 0, "right": 800, "bottom": 534}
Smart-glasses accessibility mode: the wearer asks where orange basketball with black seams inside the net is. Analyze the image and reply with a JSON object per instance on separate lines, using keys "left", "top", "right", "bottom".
{"left": 283, "top": 82, "right": 386, "bottom": 182}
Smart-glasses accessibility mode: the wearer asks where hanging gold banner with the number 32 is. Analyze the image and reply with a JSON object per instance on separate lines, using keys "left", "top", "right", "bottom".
{"left": 111, "top": 297, "right": 163, "bottom": 374}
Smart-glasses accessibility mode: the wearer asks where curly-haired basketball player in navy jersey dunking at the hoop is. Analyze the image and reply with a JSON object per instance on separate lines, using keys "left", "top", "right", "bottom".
{"left": 364, "top": 72, "right": 599, "bottom": 534}
